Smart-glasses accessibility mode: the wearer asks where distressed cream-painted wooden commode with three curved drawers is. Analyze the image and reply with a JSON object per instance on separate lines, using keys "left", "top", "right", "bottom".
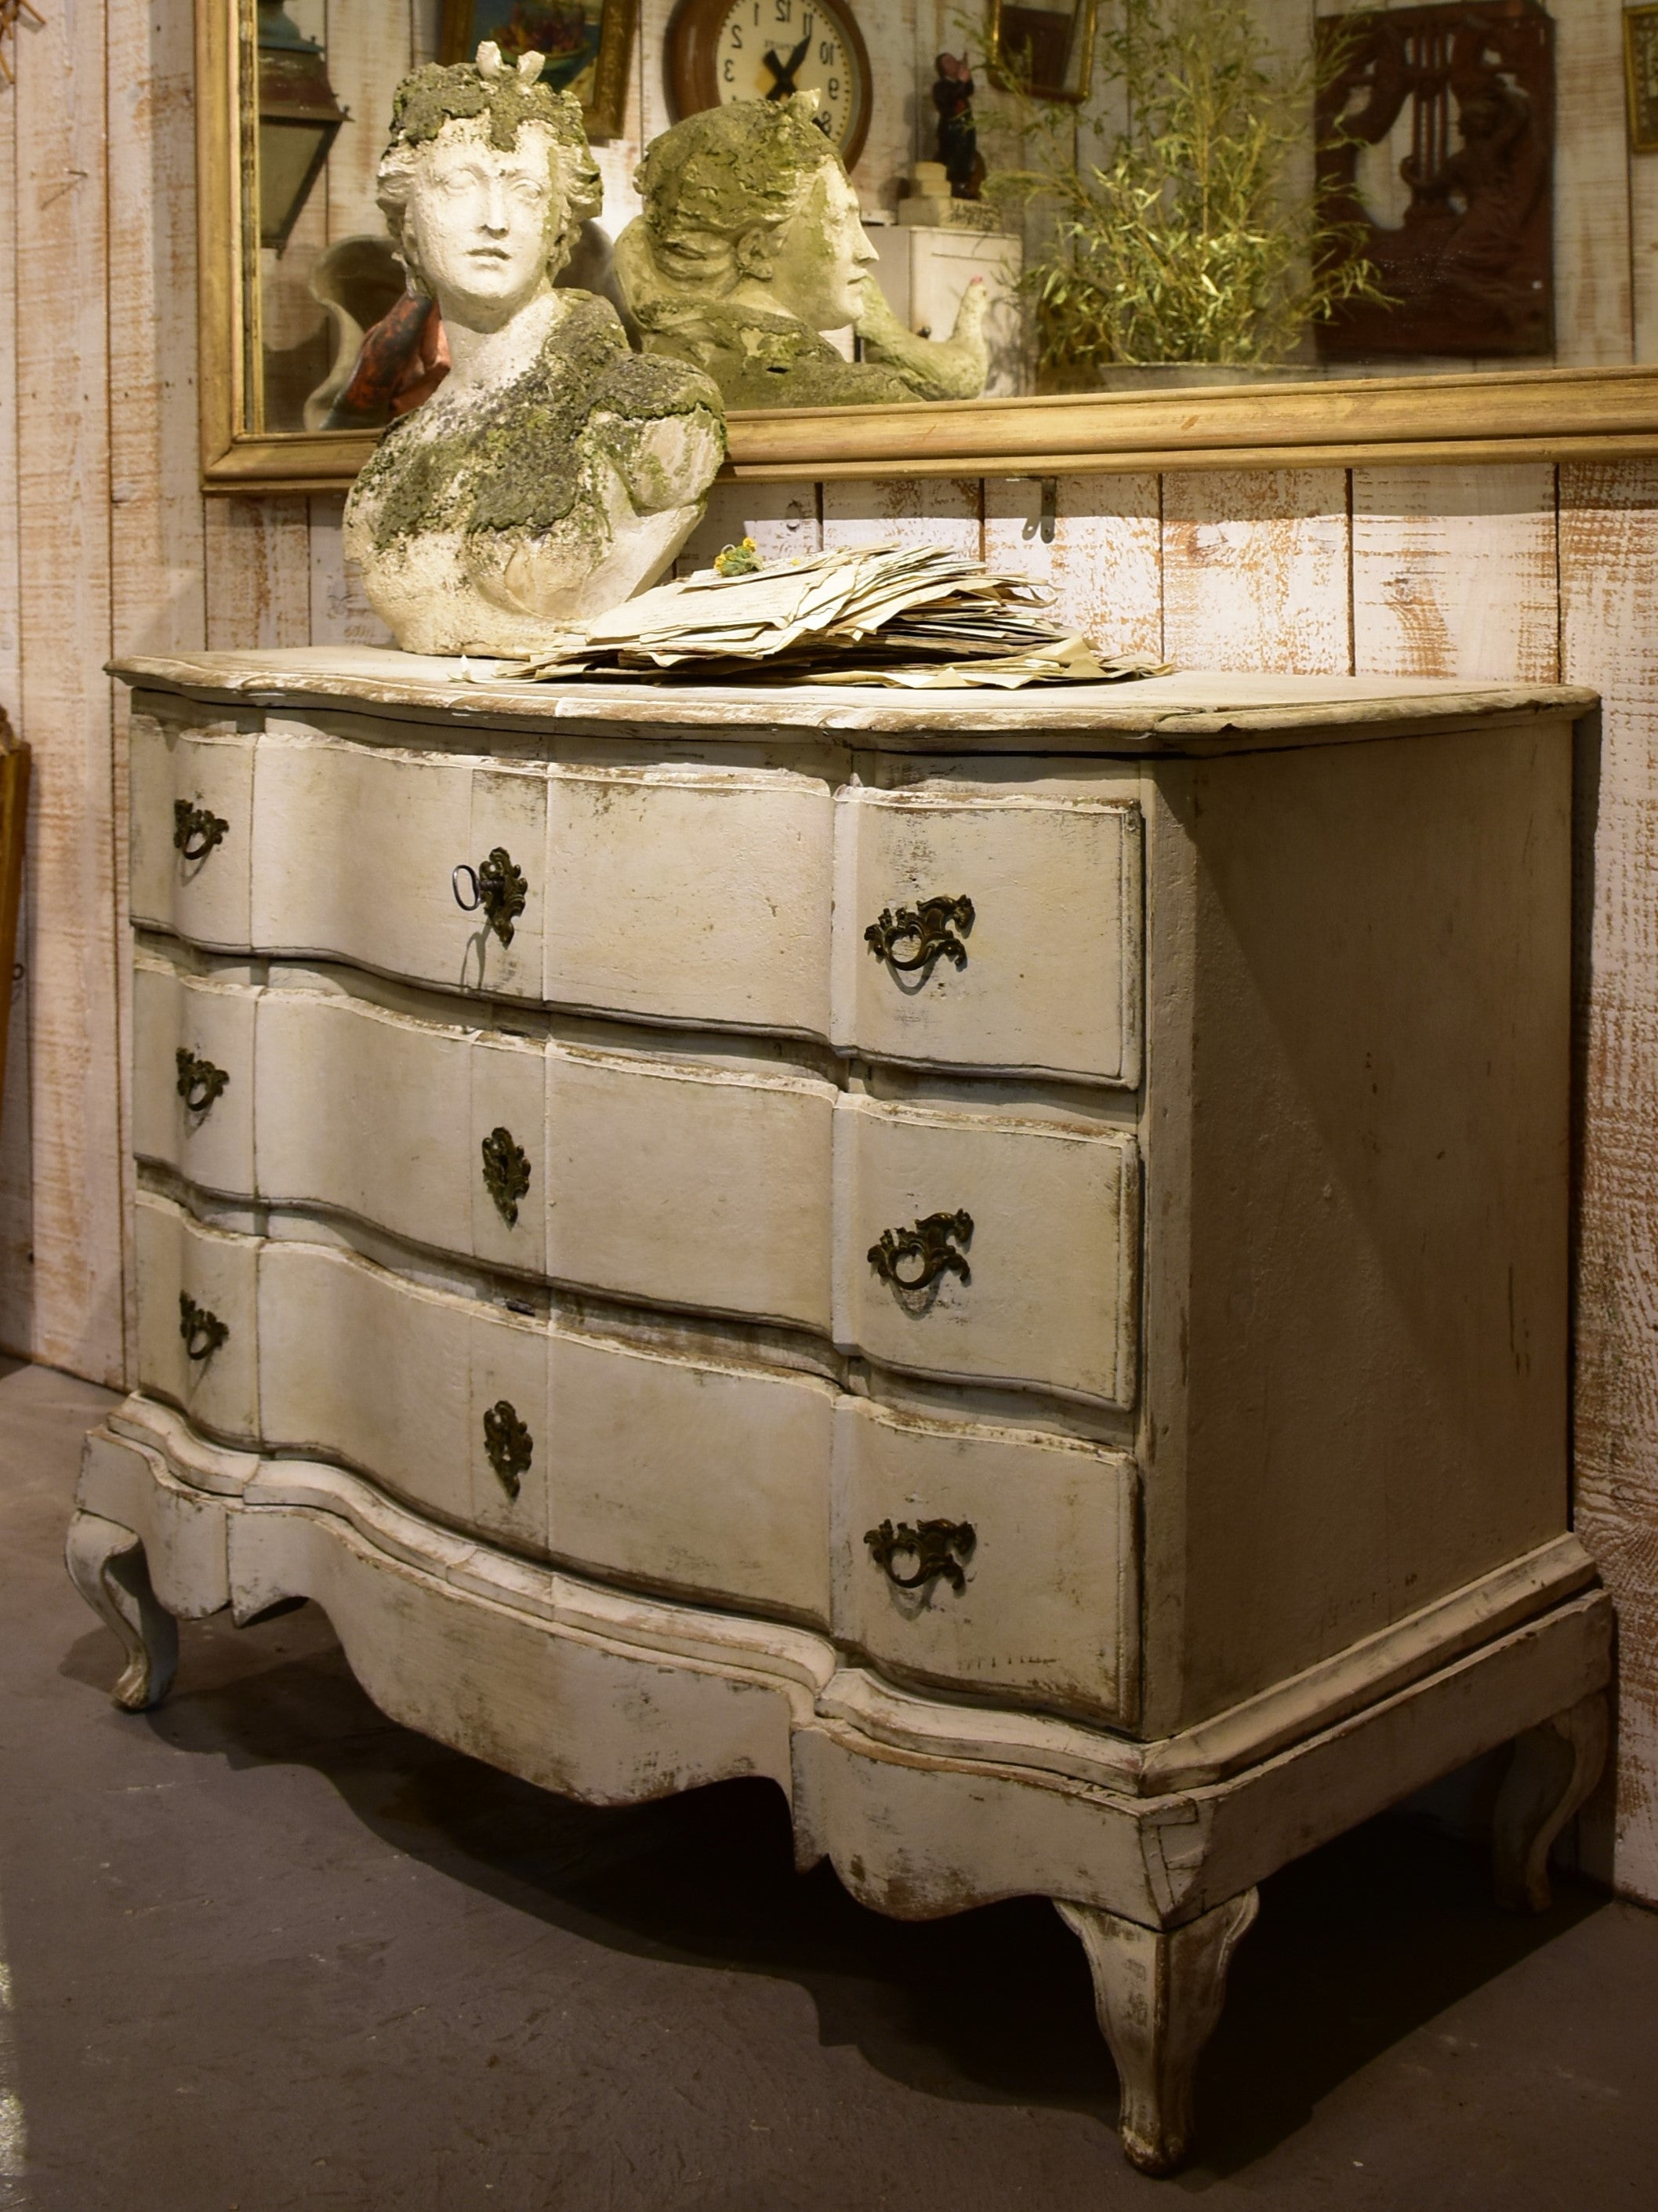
{"left": 71, "top": 650, "right": 1609, "bottom": 2172}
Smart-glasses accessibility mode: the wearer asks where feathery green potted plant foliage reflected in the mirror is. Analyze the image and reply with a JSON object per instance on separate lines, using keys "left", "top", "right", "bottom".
{"left": 986, "top": 0, "right": 1388, "bottom": 376}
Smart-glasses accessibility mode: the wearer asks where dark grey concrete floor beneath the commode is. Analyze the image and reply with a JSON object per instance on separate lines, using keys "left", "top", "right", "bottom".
{"left": 0, "top": 1363, "right": 1658, "bottom": 2212}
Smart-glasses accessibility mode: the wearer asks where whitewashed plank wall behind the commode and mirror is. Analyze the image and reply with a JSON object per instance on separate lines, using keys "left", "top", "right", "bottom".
{"left": 0, "top": 0, "right": 1658, "bottom": 1902}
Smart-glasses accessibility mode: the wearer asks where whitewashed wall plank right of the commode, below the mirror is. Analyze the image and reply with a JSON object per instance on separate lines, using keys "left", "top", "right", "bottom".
{"left": 1561, "top": 463, "right": 1658, "bottom": 1902}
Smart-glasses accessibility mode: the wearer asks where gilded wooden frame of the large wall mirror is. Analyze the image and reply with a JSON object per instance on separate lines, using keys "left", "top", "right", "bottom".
{"left": 197, "top": 0, "right": 1658, "bottom": 493}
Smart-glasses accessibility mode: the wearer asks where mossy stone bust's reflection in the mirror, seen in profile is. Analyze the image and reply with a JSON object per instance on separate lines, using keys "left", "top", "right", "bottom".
{"left": 617, "top": 93, "right": 989, "bottom": 407}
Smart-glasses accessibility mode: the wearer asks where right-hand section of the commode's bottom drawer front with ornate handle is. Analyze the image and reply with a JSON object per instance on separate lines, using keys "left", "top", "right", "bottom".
{"left": 833, "top": 1398, "right": 1138, "bottom": 1721}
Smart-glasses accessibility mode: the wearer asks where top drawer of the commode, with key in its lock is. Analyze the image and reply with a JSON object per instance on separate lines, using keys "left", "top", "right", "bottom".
{"left": 132, "top": 699, "right": 1143, "bottom": 1088}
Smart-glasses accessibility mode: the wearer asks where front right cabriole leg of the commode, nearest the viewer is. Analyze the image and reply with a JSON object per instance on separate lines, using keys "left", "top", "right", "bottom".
{"left": 1054, "top": 1889, "right": 1260, "bottom": 2174}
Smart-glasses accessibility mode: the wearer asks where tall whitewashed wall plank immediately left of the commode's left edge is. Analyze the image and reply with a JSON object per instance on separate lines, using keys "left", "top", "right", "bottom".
{"left": 16, "top": 0, "right": 124, "bottom": 1382}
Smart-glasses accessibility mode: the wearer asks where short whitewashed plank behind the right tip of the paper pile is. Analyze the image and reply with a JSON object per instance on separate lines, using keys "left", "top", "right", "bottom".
{"left": 984, "top": 476, "right": 1163, "bottom": 657}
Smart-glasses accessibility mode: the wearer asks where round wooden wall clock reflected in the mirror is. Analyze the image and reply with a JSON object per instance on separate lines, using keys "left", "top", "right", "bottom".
{"left": 663, "top": 0, "right": 871, "bottom": 168}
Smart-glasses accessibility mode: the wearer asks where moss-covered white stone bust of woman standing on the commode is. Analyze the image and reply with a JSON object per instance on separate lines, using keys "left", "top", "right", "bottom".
{"left": 345, "top": 44, "right": 725, "bottom": 655}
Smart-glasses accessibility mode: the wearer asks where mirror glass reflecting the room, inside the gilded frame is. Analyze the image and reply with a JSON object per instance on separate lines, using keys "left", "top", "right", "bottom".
{"left": 230, "top": 0, "right": 1658, "bottom": 453}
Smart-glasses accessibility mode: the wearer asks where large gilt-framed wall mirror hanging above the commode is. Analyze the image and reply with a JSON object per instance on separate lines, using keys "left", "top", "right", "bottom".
{"left": 197, "top": 0, "right": 1658, "bottom": 491}
